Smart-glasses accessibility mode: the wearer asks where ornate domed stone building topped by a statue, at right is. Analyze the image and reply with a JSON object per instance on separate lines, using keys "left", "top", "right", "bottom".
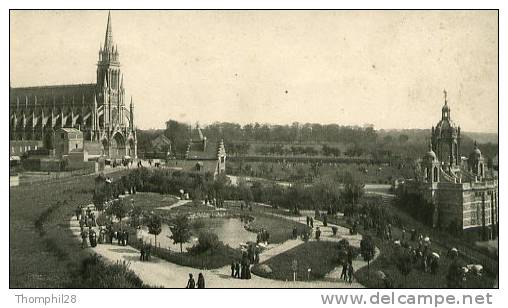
{"left": 399, "top": 91, "right": 499, "bottom": 239}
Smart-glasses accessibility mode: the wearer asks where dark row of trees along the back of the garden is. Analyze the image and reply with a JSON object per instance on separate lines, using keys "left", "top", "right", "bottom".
{"left": 123, "top": 168, "right": 364, "bottom": 210}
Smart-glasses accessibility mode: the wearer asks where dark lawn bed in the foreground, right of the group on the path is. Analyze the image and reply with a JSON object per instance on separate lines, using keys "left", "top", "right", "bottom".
{"left": 252, "top": 241, "right": 339, "bottom": 280}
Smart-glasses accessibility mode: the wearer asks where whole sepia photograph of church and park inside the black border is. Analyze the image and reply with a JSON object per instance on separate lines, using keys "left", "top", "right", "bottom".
{"left": 8, "top": 9, "right": 500, "bottom": 292}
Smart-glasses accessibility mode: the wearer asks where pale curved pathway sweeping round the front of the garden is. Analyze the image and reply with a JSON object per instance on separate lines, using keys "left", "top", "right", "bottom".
{"left": 70, "top": 205, "right": 379, "bottom": 288}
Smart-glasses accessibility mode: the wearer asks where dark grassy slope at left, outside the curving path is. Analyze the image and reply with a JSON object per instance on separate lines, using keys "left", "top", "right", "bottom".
{"left": 9, "top": 171, "right": 147, "bottom": 288}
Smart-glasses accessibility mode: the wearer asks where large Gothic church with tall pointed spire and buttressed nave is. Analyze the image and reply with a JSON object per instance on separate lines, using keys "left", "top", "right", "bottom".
{"left": 9, "top": 14, "right": 137, "bottom": 160}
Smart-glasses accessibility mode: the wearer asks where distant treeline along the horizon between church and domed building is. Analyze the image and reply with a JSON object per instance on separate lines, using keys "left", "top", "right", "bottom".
{"left": 138, "top": 120, "right": 498, "bottom": 160}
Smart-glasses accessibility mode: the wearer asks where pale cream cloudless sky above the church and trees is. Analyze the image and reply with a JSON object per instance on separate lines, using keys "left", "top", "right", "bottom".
{"left": 10, "top": 11, "right": 498, "bottom": 132}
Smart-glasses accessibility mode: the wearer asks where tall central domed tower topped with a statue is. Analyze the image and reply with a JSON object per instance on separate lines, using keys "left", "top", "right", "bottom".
{"left": 432, "top": 90, "right": 461, "bottom": 169}
